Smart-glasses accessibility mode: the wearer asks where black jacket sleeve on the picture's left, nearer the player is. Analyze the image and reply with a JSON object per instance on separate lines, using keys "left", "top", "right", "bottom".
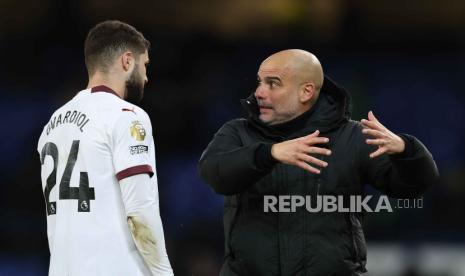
{"left": 199, "top": 121, "right": 274, "bottom": 195}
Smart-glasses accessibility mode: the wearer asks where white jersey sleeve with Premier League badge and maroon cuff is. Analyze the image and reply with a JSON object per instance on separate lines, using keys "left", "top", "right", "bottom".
{"left": 111, "top": 112, "right": 154, "bottom": 181}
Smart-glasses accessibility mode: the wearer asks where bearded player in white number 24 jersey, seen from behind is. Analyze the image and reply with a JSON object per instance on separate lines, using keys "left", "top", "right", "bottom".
{"left": 38, "top": 21, "right": 173, "bottom": 276}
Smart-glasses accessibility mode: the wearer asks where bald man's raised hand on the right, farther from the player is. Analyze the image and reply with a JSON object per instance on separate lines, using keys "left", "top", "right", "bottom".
{"left": 361, "top": 111, "right": 405, "bottom": 158}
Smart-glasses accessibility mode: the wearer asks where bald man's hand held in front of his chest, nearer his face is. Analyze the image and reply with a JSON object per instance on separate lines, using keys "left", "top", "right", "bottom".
{"left": 271, "top": 130, "right": 331, "bottom": 174}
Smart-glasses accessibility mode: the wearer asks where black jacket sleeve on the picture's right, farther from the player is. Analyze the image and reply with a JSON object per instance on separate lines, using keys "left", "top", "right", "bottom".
{"left": 362, "top": 134, "right": 439, "bottom": 198}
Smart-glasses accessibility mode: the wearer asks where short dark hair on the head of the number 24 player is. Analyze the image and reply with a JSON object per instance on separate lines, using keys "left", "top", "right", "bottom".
{"left": 84, "top": 20, "right": 150, "bottom": 75}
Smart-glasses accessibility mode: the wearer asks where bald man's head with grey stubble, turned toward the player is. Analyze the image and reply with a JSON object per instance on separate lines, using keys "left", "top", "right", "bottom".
{"left": 255, "top": 49, "right": 324, "bottom": 125}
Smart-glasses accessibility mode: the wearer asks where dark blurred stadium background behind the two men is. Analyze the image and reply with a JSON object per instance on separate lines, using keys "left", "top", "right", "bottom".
{"left": 0, "top": 0, "right": 465, "bottom": 276}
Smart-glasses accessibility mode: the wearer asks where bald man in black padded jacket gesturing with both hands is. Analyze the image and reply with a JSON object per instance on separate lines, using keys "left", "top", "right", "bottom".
{"left": 199, "top": 49, "right": 438, "bottom": 276}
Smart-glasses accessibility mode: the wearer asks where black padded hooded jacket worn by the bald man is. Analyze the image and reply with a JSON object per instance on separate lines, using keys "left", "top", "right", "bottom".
{"left": 199, "top": 78, "right": 438, "bottom": 276}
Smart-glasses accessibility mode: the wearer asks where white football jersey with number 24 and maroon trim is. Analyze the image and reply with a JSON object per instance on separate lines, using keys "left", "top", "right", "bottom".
{"left": 38, "top": 86, "right": 165, "bottom": 276}
